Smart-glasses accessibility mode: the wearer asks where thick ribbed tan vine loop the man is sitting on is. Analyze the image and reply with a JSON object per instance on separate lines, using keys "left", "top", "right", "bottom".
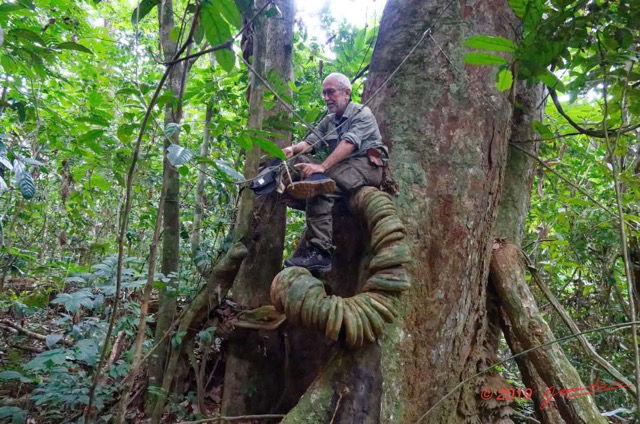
{"left": 271, "top": 187, "right": 411, "bottom": 347}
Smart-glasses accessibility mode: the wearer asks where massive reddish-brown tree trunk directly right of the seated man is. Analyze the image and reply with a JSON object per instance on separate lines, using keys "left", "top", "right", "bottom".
{"left": 285, "top": 0, "right": 517, "bottom": 423}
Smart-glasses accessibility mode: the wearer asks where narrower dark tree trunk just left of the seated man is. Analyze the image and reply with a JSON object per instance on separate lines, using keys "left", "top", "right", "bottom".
{"left": 222, "top": 0, "right": 295, "bottom": 415}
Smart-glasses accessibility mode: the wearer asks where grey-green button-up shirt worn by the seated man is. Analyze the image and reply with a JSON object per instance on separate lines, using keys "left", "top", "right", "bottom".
{"left": 305, "top": 102, "right": 382, "bottom": 157}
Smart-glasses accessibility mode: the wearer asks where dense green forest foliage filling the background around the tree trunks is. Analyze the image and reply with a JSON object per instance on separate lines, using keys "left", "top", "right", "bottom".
{"left": 0, "top": 0, "right": 640, "bottom": 422}
